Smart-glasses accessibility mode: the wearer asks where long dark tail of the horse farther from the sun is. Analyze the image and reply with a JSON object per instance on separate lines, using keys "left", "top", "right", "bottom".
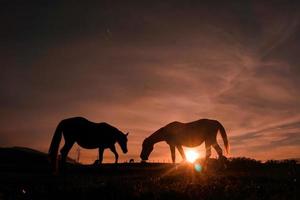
{"left": 48, "top": 122, "right": 63, "bottom": 171}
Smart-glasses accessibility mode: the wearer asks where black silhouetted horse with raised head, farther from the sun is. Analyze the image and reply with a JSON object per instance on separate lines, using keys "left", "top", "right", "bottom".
{"left": 49, "top": 117, "right": 128, "bottom": 171}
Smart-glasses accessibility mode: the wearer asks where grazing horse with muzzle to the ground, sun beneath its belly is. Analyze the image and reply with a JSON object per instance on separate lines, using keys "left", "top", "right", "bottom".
{"left": 140, "top": 119, "right": 229, "bottom": 163}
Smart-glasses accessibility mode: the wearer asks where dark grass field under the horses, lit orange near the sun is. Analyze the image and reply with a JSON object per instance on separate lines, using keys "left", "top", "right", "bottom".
{"left": 0, "top": 156, "right": 300, "bottom": 200}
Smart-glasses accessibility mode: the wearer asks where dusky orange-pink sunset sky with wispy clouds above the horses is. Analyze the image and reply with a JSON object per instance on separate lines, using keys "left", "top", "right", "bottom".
{"left": 0, "top": 0, "right": 300, "bottom": 163}
